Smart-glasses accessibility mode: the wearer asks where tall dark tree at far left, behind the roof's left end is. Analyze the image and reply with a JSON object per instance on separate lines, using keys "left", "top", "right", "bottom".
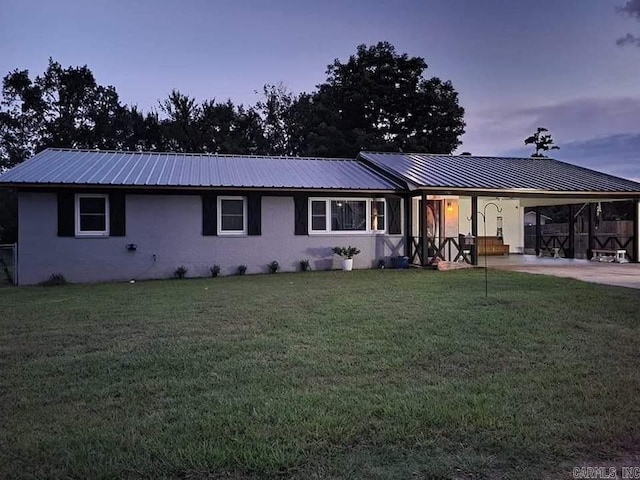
{"left": 0, "top": 59, "right": 123, "bottom": 167}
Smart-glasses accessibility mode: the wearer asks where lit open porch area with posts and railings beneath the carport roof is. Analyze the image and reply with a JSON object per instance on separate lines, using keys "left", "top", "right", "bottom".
{"left": 405, "top": 191, "right": 640, "bottom": 266}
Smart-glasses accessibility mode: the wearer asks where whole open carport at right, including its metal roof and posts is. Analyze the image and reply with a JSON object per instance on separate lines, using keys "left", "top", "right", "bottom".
{"left": 358, "top": 152, "right": 640, "bottom": 266}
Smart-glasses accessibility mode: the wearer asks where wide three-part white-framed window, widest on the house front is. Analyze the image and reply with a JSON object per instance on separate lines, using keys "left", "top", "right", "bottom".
{"left": 309, "top": 198, "right": 387, "bottom": 233}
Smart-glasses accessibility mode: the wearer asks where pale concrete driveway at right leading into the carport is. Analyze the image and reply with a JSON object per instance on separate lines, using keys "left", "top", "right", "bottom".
{"left": 478, "top": 254, "right": 640, "bottom": 289}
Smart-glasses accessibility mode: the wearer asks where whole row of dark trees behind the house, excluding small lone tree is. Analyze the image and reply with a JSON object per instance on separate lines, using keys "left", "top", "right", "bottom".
{"left": 0, "top": 42, "right": 465, "bottom": 242}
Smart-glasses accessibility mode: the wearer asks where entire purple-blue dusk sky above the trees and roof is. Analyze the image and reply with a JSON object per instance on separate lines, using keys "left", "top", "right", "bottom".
{"left": 0, "top": 0, "right": 640, "bottom": 179}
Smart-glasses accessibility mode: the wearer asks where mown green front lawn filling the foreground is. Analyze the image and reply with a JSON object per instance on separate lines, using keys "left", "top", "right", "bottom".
{"left": 0, "top": 270, "right": 640, "bottom": 479}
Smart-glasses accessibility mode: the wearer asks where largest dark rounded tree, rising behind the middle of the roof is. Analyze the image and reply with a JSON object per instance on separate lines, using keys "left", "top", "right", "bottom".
{"left": 304, "top": 42, "right": 465, "bottom": 157}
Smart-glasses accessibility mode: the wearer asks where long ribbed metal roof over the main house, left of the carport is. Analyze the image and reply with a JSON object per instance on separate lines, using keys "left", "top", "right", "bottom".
{"left": 0, "top": 148, "right": 399, "bottom": 190}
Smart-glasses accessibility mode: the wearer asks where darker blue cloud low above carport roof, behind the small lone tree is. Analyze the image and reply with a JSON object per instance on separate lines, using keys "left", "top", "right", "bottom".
{"left": 501, "top": 133, "right": 640, "bottom": 181}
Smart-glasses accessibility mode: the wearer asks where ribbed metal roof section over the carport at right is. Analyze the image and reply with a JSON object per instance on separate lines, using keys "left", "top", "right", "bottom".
{"left": 359, "top": 152, "right": 640, "bottom": 195}
